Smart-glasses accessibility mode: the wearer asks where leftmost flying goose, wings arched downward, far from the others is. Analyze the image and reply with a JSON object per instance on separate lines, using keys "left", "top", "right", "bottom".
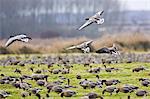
{"left": 5, "top": 34, "right": 31, "bottom": 47}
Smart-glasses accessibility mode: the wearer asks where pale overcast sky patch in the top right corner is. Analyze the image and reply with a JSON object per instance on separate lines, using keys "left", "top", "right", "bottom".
{"left": 119, "top": 0, "right": 150, "bottom": 10}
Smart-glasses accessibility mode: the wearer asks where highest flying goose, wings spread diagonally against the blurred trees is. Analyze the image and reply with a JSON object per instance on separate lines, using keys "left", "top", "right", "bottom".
{"left": 78, "top": 11, "right": 104, "bottom": 30}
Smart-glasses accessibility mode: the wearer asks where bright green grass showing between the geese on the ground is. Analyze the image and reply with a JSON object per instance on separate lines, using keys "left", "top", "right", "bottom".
{"left": 0, "top": 55, "right": 150, "bottom": 99}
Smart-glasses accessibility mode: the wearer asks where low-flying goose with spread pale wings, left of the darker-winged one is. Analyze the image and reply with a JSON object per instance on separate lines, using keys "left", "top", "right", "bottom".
{"left": 66, "top": 40, "right": 93, "bottom": 53}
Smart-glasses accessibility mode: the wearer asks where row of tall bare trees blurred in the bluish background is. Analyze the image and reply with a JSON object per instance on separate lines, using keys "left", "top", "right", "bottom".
{"left": 0, "top": 0, "right": 120, "bottom": 37}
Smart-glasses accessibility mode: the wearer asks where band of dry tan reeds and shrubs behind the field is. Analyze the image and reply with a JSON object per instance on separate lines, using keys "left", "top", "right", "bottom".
{"left": 0, "top": 33, "right": 150, "bottom": 54}
